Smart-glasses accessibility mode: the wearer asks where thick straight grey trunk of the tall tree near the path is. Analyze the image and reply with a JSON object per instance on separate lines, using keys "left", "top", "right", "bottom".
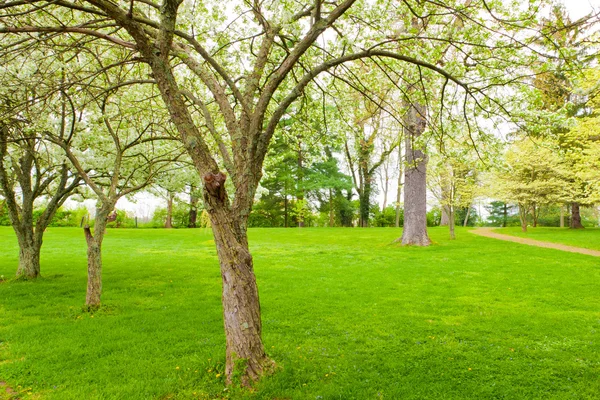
{"left": 401, "top": 105, "right": 431, "bottom": 246}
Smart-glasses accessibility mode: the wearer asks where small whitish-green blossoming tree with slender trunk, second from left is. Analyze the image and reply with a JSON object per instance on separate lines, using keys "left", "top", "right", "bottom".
{"left": 46, "top": 73, "right": 182, "bottom": 310}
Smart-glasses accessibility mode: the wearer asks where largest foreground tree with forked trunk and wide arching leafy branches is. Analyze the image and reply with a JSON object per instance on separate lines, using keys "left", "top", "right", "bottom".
{"left": 0, "top": 0, "right": 584, "bottom": 384}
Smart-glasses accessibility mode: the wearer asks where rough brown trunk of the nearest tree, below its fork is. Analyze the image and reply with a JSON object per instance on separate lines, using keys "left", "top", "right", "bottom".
{"left": 204, "top": 174, "right": 275, "bottom": 385}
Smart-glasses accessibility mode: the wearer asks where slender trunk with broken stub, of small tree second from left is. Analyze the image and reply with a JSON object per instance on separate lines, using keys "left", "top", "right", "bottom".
{"left": 83, "top": 204, "right": 116, "bottom": 311}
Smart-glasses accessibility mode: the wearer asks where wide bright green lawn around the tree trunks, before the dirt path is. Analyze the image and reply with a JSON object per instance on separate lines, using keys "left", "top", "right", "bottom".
{"left": 0, "top": 228, "right": 600, "bottom": 400}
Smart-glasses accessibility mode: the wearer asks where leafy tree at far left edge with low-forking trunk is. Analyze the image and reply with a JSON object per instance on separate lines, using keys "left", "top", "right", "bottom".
{"left": 0, "top": 65, "right": 81, "bottom": 279}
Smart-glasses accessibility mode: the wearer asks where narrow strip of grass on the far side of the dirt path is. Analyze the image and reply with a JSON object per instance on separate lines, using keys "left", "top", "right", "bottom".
{"left": 494, "top": 227, "right": 600, "bottom": 250}
